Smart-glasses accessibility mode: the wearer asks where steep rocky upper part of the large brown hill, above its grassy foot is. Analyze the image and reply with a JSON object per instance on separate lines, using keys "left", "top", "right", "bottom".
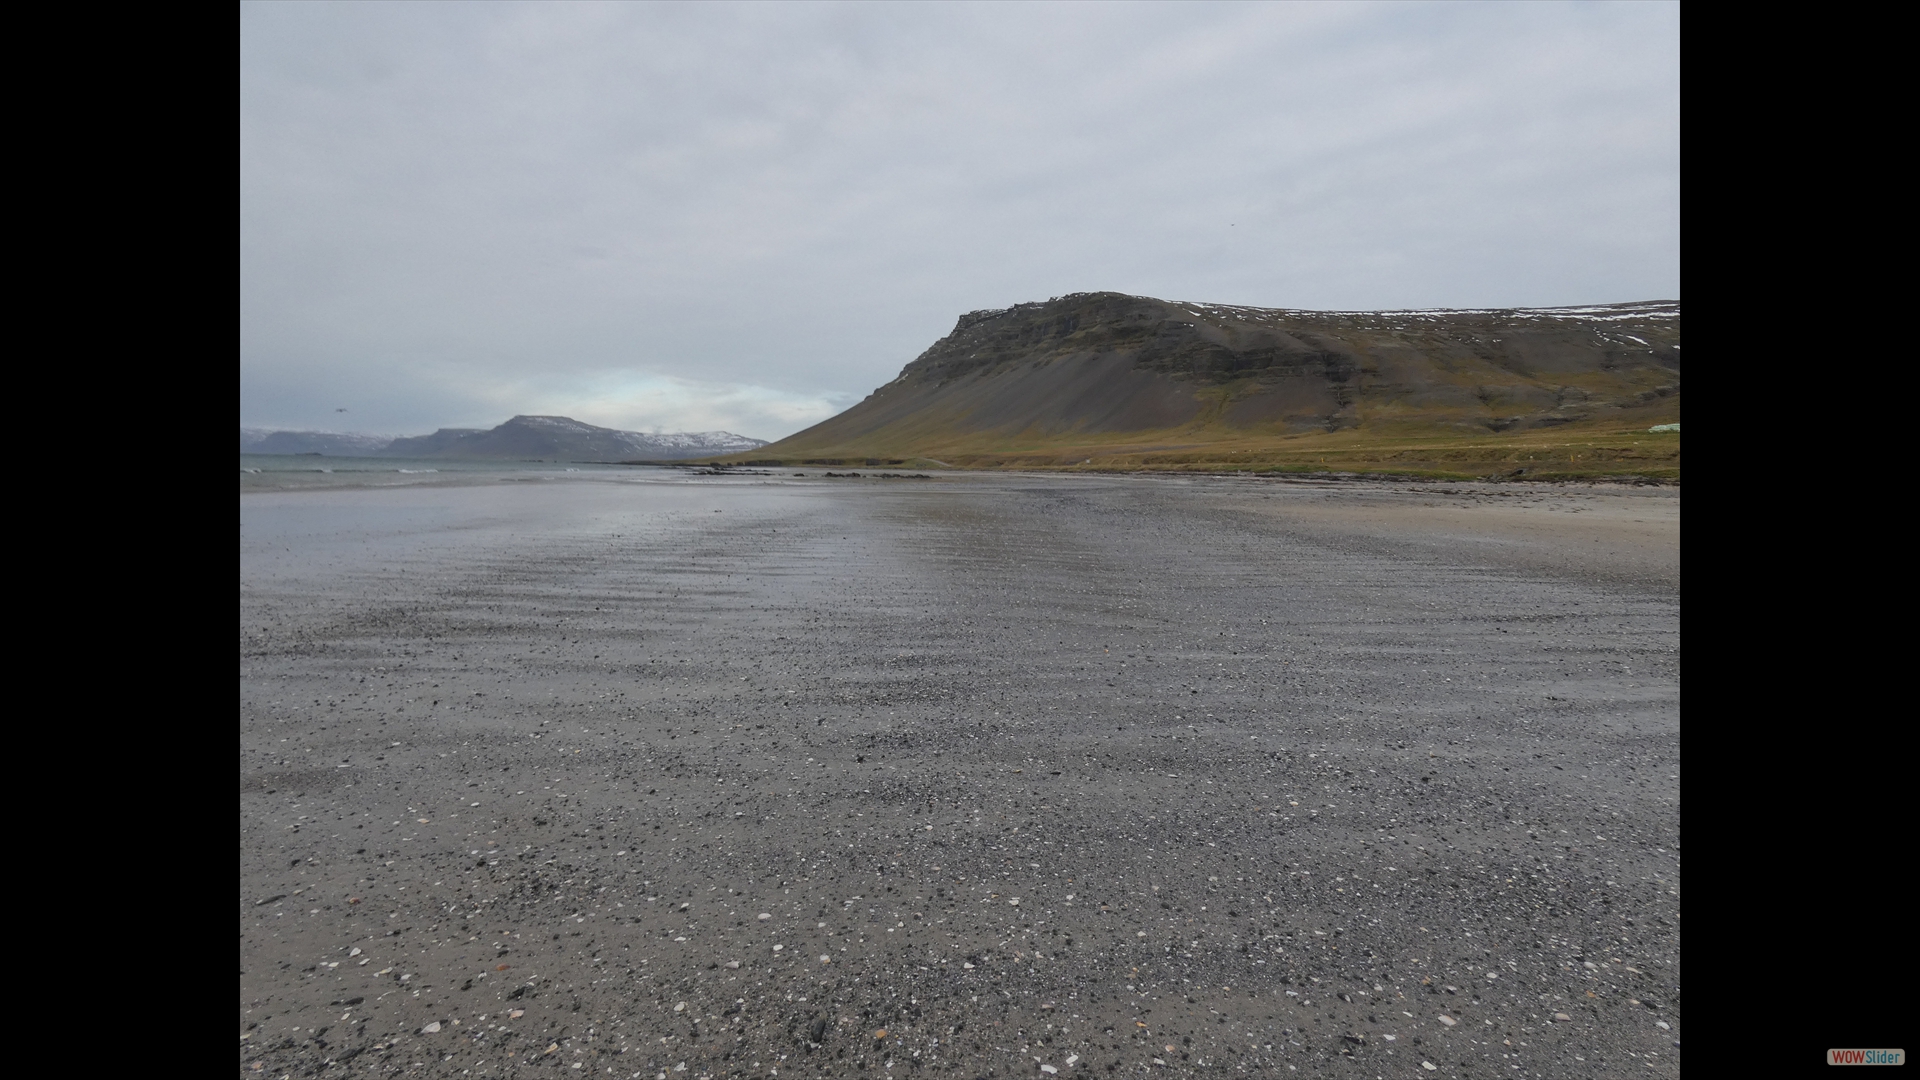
{"left": 768, "top": 292, "right": 1680, "bottom": 452}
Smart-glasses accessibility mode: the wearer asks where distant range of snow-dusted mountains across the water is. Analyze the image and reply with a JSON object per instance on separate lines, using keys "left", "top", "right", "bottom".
{"left": 240, "top": 417, "right": 766, "bottom": 461}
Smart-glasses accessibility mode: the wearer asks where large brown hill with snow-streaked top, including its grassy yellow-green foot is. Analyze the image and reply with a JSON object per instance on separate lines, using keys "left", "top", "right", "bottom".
{"left": 725, "top": 292, "right": 1680, "bottom": 475}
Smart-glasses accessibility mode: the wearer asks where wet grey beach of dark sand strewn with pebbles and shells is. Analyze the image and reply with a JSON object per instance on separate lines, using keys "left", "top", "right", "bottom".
{"left": 240, "top": 475, "right": 1680, "bottom": 1080}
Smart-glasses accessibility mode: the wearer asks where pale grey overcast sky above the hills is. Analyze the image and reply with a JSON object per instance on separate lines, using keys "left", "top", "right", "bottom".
{"left": 240, "top": 2, "right": 1680, "bottom": 438}
